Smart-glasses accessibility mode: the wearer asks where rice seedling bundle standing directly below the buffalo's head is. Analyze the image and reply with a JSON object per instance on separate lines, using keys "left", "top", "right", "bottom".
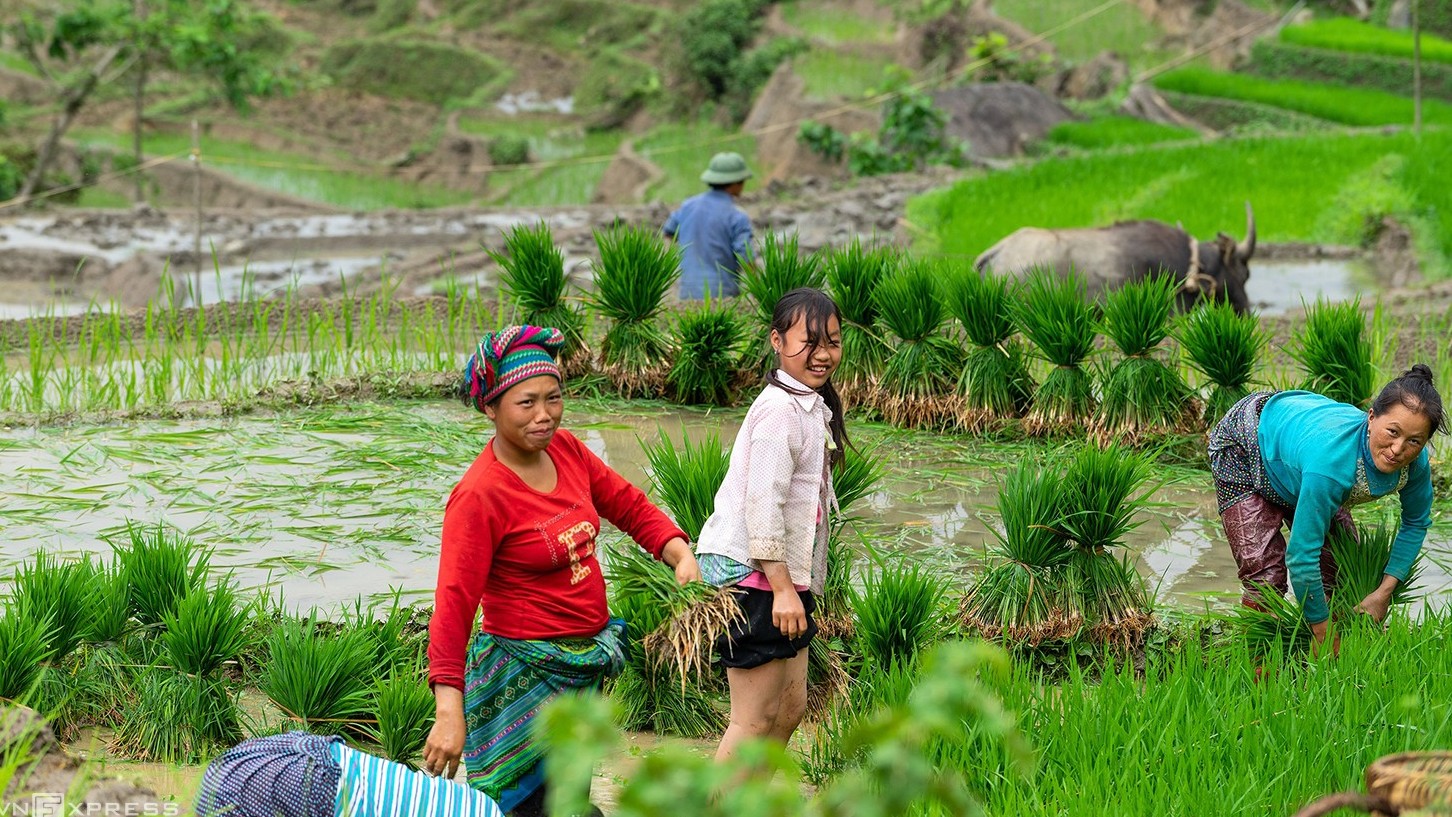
{"left": 1178, "top": 303, "right": 1271, "bottom": 422}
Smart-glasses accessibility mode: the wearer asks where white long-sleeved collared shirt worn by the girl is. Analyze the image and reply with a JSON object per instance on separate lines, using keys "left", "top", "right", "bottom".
{"left": 696, "top": 370, "right": 835, "bottom": 594}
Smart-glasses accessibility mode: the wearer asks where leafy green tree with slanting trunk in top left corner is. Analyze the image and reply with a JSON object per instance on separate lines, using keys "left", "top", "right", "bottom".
{"left": 12, "top": 0, "right": 285, "bottom": 199}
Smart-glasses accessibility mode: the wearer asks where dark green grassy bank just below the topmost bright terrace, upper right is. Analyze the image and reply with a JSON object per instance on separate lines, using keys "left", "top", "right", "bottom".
{"left": 1250, "top": 39, "right": 1452, "bottom": 100}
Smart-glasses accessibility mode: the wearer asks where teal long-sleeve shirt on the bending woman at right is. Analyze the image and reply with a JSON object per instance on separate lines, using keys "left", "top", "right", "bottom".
{"left": 1257, "top": 392, "right": 1432, "bottom": 624}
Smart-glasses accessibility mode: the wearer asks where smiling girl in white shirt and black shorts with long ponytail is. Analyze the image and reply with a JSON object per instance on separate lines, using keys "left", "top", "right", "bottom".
{"left": 697, "top": 289, "right": 847, "bottom": 760}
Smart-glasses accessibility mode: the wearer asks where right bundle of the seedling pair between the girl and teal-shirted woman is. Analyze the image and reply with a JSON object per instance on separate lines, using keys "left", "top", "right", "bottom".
{"left": 1059, "top": 446, "right": 1154, "bottom": 646}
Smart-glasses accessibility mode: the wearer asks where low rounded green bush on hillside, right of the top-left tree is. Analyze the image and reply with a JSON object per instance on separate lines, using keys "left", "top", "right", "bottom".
{"left": 319, "top": 38, "right": 504, "bottom": 104}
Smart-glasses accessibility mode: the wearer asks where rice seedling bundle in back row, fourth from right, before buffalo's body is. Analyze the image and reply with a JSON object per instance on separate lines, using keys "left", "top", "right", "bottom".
{"left": 1011, "top": 268, "right": 1096, "bottom": 434}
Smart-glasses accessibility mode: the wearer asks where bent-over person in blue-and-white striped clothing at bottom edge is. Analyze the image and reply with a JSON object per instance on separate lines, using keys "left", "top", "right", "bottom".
{"left": 196, "top": 731, "right": 504, "bottom": 817}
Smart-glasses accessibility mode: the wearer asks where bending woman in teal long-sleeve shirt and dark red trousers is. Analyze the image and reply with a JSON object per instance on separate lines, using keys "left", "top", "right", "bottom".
{"left": 1210, "top": 363, "right": 1446, "bottom": 643}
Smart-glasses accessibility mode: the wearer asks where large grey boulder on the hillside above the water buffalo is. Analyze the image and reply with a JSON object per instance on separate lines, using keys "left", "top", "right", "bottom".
{"left": 932, "top": 83, "right": 1074, "bottom": 158}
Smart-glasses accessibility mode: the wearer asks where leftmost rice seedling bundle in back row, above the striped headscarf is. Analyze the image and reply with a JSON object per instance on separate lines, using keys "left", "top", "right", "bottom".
{"left": 488, "top": 221, "right": 590, "bottom": 377}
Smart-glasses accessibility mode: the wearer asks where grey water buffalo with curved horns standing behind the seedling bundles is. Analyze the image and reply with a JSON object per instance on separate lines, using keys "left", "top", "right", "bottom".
{"left": 973, "top": 202, "right": 1256, "bottom": 313}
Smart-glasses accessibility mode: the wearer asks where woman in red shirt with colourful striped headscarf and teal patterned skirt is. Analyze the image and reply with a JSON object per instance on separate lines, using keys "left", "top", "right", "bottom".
{"left": 424, "top": 327, "right": 700, "bottom": 816}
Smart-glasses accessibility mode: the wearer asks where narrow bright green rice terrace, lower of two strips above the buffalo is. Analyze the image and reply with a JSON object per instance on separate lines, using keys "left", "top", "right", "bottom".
{"left": 1154, "top": 68, "right": 1452, "bottom": 126}
